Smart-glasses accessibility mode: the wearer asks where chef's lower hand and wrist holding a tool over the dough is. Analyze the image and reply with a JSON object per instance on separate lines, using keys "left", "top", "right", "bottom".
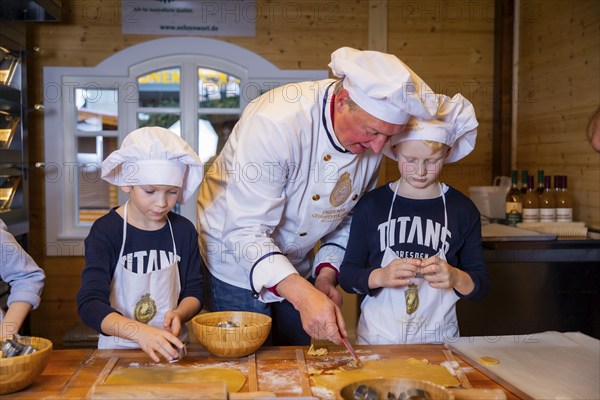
{"left": 277, "top": 274, "right": 347, "bottom": 344}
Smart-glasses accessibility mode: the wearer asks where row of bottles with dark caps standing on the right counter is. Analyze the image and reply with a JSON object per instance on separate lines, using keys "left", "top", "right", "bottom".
{"left": 506, "top": 170, "right": 573, "bottom": 226}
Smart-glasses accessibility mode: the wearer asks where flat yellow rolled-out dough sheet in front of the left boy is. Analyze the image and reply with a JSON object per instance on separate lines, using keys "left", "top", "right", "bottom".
{"left": 105, "top": 367, "right": 246, "bottom": 393}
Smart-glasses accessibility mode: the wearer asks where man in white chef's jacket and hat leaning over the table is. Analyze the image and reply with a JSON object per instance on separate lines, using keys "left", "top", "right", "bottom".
{"left": 197, "top": 47, "right": 437, "bottom": 345}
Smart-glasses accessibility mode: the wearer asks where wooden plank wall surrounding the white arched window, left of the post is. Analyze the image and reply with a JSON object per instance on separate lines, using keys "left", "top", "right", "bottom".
{"left": 27, "top": 0, "right": 368, "bottom": 347}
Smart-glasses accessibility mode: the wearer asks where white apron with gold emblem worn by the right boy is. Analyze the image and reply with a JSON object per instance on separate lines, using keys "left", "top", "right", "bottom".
{"left": 357, "top": 184, "right": 459, "bottom": 344}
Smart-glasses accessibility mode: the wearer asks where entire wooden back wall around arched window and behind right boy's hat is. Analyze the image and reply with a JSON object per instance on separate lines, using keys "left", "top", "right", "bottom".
{"left": 27, "top": 0, "right": 493, "bottom": 347}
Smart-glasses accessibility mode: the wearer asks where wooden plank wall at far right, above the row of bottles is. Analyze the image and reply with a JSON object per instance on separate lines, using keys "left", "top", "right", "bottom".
{"left": 516, "top": 0, "right": 600, "bottom": 229}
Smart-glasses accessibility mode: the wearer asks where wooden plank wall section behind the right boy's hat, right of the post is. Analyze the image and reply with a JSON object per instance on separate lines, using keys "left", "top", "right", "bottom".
{"left": 386, "top": 0, "right": 494, "bottom": 194}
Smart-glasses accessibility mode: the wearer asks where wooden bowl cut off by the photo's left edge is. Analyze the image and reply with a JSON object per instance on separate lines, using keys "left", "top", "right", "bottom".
{"left": 0, "top": 337, "right": 52, "bottom": 394}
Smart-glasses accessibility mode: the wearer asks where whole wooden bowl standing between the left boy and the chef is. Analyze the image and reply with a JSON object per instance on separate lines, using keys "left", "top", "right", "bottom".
{"left": 192, "top": 311, "right": 271, "bottom": 358}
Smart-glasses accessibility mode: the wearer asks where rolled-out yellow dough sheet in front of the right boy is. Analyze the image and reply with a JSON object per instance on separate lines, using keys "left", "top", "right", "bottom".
{"left": 311, "top": 358, "right": 460, "bottom": 393}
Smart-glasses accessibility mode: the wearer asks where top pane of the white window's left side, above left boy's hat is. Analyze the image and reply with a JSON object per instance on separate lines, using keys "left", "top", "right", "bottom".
{"left": 75, "top": 88, "right": 119, "bottom": 132}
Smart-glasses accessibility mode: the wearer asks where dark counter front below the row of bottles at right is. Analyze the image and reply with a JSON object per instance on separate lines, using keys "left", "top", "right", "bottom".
{"left": 457, "top": 239, "right": 600, "bottom": 338}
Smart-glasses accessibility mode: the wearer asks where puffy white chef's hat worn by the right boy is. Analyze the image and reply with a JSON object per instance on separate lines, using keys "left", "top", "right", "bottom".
{"left": 383, "top": 93, "right": 479, "bottom": 163}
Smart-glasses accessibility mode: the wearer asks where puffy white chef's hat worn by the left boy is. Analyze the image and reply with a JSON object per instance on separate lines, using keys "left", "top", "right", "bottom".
{"left": 102, "top": 127, "right": 204, "bottom": 203}
